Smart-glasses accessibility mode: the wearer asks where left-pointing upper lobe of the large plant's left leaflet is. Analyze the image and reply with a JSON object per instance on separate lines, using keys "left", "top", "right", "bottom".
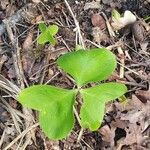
{"left": 18, "top": 85, "right": 74, "bottom": 111}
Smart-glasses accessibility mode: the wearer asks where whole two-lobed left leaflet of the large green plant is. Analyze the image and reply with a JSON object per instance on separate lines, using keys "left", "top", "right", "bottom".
{"left": 18, "top": 85, "right": 76, "bottom": 139}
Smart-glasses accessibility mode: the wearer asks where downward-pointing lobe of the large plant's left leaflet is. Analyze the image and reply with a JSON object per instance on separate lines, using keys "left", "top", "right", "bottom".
{"left": 39, "top": 101, "right": 74, "bottom": 140}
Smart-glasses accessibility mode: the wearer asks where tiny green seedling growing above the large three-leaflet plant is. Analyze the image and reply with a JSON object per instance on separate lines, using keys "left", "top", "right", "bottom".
{"left": 37, "top": 23, "right": 58, "bottom": 45}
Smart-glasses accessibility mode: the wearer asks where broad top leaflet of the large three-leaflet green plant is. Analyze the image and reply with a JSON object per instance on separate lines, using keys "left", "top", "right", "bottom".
{"left": 57, "top": 48, "right": 116, "bottom": 86}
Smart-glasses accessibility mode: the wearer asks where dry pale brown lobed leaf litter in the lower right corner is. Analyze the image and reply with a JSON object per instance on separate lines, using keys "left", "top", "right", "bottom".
{"left": 104, "top": 94, "right": 150, "bottom": 150}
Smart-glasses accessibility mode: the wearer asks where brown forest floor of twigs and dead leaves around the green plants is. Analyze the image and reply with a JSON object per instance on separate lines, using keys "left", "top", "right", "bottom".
{"left": 0, "top": 0, "right": 150, "bottom": 150}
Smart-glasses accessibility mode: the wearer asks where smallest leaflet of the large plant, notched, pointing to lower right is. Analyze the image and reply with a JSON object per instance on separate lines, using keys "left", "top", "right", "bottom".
{"left": 80, "top": 83, "right": 127, "bottom": 131}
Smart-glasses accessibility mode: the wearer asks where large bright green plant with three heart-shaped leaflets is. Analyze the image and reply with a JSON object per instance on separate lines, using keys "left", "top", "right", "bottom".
{"left": 18, "top": 48, "right": 127, "bottom": 140}
